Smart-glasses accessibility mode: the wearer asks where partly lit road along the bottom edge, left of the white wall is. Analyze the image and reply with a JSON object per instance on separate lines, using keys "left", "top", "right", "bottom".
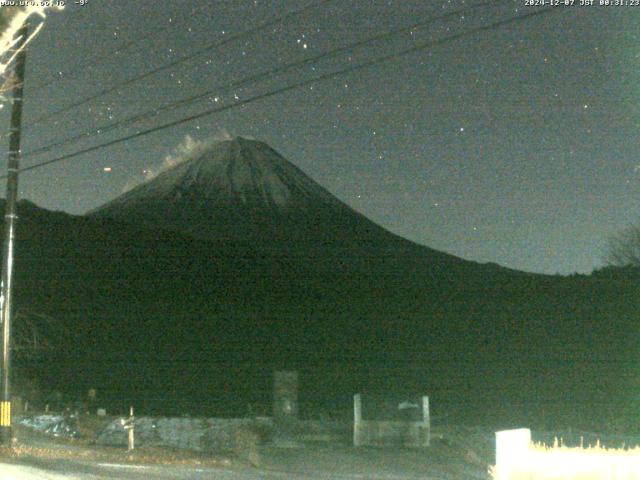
{"left": 0, "top": 426, "right": 493, "bottom": 480}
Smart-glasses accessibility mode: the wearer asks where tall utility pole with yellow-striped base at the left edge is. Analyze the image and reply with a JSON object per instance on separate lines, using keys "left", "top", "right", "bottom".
{"left": 0, "top": 23, "right": 28, "bottom": 446}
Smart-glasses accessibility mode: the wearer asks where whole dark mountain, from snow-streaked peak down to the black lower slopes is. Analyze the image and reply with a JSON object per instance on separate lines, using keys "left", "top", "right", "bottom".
{"left": 0, "top": 139, "right": 640, "bottom": 428}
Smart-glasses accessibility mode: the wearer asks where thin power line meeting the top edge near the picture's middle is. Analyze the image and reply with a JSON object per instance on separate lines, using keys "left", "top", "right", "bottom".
{"left": 24, "top": 0, "right": 332, "bottom": 128}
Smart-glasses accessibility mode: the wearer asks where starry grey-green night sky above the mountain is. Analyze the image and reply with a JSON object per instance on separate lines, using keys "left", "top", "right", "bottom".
{"left": 0, "top": 0, "right": 640, "bottom": 274}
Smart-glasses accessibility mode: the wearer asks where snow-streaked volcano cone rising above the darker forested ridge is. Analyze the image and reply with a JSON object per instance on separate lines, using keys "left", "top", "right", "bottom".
{"left": 87, "top": 137, "right": 471, "bottom": 274}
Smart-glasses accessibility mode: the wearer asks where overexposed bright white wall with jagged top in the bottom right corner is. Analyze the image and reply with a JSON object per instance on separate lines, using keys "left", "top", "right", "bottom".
{"left": 492, "top": 429, "right": 640, "bottom": 480}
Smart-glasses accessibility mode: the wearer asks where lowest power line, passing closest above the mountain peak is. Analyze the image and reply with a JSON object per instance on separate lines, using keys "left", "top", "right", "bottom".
{"left": 12, "top": 7, "right": 565, "bottom": 178}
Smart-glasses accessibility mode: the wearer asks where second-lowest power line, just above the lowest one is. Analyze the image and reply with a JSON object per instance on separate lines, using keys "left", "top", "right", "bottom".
{"left": 23, "top": 0, "right": 496, "bottom": 157}
